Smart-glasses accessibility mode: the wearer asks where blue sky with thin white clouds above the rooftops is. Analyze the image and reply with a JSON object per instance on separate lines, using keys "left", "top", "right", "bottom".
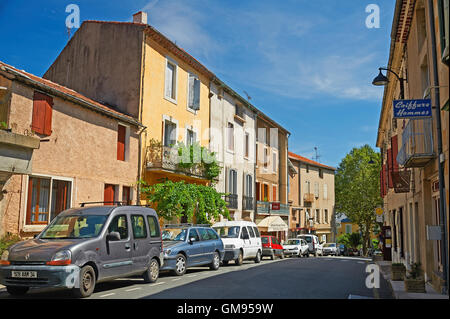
{"left": 0, "top": 0, "right": 395, "bottom": 167}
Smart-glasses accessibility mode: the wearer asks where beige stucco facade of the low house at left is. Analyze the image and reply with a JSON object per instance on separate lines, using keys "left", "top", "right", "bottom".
{"left": 0, "top": 62, "right": 140, "bottom": 237}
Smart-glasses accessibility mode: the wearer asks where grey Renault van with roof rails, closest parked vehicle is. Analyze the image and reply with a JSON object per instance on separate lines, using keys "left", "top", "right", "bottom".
{"left": 0, "top": 206, "right": 163, "bottom": 297}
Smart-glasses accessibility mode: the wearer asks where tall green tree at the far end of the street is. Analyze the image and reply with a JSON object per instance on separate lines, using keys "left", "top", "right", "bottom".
{"left": 335, "top": 145, "right": 383, "bottom": 255}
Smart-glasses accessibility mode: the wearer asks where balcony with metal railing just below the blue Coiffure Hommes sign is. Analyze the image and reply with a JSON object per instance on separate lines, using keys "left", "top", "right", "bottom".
{"left": 397, "top": 118, "right": 434, "bottom": 167}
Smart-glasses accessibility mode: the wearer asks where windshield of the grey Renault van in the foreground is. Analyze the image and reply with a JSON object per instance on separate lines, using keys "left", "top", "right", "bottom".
{"left": 40, "top": 215, "right": 108, "bottom": 239}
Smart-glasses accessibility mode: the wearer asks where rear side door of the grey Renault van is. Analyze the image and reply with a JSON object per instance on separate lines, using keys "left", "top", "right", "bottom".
{"left": 130, "top": 213, "right": 150, "bottom": 272}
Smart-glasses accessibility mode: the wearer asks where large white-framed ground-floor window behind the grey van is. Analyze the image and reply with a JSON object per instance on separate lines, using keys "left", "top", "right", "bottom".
{"left": 26, "top": 177, "right": 72, "bottom": 225}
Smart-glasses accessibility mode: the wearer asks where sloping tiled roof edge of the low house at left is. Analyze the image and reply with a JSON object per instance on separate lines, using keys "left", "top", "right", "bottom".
{"left": 0, "top": 61, "right": 143, "bottom": 126}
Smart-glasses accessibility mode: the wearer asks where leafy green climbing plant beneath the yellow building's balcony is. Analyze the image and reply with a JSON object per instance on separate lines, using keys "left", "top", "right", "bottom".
{"left": 139, "top": 180, "right": 230, "bottom": 224}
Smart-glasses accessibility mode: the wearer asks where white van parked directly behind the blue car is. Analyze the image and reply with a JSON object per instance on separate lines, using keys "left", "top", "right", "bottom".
{"left": 212, "top": 220, "right": 262, "bottom": 265}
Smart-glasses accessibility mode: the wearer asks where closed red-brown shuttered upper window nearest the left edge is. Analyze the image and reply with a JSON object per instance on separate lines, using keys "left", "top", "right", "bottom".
{"left": 31, "top": 91, "right": 53, "bottom": 136}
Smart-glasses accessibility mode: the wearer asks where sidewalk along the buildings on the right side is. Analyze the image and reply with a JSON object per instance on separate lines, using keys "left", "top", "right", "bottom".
{"left": 375, "top": 261, "right": 448, "bottom": 300}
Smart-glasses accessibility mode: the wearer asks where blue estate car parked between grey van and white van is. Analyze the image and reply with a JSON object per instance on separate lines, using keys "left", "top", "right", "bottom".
{"left": 161, "top": 224, "right": 225, "bottom": 276}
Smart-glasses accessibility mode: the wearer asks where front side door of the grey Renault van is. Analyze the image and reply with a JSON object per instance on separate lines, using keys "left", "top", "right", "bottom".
{"left": 103, "top": 214, "right": 133, "bottom": 279}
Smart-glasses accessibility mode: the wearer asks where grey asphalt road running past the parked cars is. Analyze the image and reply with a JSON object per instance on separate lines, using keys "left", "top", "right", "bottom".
{"left": 0, "top": 257, "right": 392, "bottom": 299}
